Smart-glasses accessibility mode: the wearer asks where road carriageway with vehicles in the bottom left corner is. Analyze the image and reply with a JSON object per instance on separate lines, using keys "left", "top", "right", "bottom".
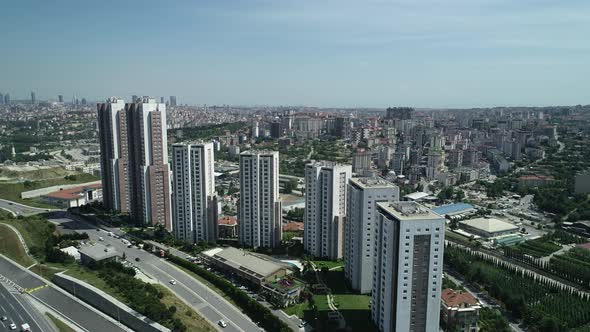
{"left": 0, "top": 283, "right": 45, "bottom": 331}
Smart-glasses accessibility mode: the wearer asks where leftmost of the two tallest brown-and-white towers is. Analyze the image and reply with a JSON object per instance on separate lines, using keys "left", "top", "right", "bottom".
{"left": 97, "top": 95, "right": 129, "bottom": 212}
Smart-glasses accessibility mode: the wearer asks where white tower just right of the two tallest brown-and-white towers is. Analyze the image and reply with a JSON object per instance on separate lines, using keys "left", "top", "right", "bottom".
{"left": 172, "top": 143, "right": 218, "bottom": 243}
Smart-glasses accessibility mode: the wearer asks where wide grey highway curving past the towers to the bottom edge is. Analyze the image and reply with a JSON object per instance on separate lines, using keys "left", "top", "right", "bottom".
{"left": 49, "top": 218, "right": 262, "bottom": 332}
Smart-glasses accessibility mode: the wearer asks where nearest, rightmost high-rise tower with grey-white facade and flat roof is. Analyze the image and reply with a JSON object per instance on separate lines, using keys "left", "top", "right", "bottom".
{"left": 371, "top": 202, "right": 445, "bottom": 332}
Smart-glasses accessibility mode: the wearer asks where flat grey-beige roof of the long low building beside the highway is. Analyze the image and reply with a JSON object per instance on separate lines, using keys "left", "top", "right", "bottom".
{"left": 203, "top": 247, "right": 287, "bottom": 278}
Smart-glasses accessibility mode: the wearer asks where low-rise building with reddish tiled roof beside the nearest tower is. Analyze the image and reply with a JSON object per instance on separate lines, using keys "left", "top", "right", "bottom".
{"left": 440, "top": 288, "right": 481, "bottom": 332}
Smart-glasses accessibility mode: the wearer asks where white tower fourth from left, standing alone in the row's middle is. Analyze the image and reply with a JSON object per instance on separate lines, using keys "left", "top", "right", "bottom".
{"left": 238, "top": 151, "right": 282, "bottom": 248}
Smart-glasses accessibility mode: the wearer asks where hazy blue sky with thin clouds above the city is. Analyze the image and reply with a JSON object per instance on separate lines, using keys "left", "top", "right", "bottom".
{"left": 0, "top": 0, "right": 590, "bottom": 108}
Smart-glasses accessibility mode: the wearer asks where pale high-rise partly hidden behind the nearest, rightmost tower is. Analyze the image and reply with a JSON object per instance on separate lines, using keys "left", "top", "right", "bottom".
{"left": 344, "top": 177, "right": 399, "bottom": 294}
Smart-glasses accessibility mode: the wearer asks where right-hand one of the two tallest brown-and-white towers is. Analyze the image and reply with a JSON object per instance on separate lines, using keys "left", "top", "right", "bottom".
{"left": 125, "top": 97, "right": 172, "bottom": 231}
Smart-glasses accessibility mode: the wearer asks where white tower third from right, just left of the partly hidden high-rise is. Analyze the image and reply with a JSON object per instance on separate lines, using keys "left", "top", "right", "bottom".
{"left": 303, "top": 161, "right": 352, "bottom": 260}
